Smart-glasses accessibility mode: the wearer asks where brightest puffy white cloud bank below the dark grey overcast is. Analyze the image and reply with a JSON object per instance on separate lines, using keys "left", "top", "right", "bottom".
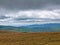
{"left": 5, "top": 10, "right": 60, "bottom": 19}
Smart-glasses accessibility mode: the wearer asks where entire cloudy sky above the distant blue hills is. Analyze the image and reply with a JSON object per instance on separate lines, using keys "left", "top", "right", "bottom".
{"left": 0, "top": 0, "right": 60, "bottom": 26}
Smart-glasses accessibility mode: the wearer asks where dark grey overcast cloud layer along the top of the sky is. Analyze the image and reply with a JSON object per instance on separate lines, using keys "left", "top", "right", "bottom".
{"left": 0, "top": 0, "right": 60, "bottom": 9}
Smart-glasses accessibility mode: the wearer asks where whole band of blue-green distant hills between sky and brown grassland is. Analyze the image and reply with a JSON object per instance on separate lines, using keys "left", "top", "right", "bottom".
{"left": 0, "top": 23, "right": 60, "bottom": 32}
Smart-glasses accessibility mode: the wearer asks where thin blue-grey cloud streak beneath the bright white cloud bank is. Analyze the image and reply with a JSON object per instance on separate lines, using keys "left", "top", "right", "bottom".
{"left": 14, "top": 18, "right": 60, "bottom": 22}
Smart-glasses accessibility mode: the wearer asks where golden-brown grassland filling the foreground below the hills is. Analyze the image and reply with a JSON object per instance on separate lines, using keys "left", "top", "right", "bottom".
{"left": 0, "top": 31, "right": 60, "bottom": 45}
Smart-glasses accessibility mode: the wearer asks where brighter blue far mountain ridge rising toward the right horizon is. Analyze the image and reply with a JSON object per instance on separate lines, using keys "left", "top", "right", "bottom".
{"left": 23, "top": 23, "right": 60, "bottom": 28}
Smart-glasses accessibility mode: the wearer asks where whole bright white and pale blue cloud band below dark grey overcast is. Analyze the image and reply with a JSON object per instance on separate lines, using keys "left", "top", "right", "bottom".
{"left": 0, "top": 10, "right": 60, "bottom": 25}
